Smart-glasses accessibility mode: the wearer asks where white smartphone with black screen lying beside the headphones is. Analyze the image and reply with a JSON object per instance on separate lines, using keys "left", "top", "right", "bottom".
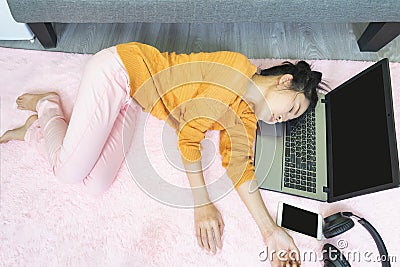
{"left": 276, "top": 202, "right": 322, "bottom": 240}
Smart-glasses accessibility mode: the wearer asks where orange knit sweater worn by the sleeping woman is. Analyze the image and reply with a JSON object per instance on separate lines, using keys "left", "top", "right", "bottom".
{"left": 116, "top": 42, "right": 257, "bottom": 189}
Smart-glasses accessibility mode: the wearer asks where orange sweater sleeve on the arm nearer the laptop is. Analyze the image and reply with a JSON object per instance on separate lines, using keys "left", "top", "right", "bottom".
{"left": 219, "top": 102, "right": 257, "bottom": 190}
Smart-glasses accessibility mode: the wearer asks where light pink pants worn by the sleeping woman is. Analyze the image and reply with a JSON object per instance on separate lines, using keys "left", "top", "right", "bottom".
{"left": 26, "top": 47, "right": 140, "bottom": 195}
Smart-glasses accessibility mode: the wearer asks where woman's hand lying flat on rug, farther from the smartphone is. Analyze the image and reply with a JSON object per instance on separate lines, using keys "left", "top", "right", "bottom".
{"left": 194, "top": 203, "right": 225, "bottom": 254}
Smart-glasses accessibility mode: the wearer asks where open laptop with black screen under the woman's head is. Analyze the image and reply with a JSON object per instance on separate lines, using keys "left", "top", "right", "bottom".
{"left": 254, "top": 58, "right": 399, "bottom": 202}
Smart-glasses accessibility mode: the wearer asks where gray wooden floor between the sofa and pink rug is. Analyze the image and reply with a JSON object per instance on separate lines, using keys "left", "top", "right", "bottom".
{"left": 0, "top": 23, "right": 400, "bottom": 62}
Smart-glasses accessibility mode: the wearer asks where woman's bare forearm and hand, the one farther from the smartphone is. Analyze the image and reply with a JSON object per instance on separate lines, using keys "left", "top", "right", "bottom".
{"left": 182, "top": 157, "right": 225, "bottom": 254}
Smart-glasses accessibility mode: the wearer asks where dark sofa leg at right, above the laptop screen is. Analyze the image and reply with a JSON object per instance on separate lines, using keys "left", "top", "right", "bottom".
{"left": 357, "top": 22, "right": 400, "bottom": 52}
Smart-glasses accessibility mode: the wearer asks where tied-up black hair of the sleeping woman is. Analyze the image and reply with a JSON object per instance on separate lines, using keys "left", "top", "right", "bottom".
{"left": 260, "top": 61, "right": 328, "bottom": 109}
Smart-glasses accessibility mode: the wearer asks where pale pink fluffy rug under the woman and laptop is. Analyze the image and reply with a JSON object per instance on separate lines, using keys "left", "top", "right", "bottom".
{"left": 0, "top": 48, "right": 400, "bottom": 266}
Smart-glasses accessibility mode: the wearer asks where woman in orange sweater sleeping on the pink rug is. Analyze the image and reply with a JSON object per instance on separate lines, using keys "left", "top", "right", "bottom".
{"left": 0, "top": 42, "right": 322, "bottom": 266}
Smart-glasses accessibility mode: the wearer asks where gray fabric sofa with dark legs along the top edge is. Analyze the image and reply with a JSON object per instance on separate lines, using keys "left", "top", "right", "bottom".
{"left": 7, "top": 0, "right": 400, "bottom": 51}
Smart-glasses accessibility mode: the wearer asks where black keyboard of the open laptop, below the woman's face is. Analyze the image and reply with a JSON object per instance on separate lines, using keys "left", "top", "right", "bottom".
{"left": 283, "top": 110, "right": 316, "bottom": 193}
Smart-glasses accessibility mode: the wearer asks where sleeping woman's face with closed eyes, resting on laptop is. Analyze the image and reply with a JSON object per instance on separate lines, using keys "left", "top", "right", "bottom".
{"left": 260, "top": 89, "right": 310, "bottom": 124}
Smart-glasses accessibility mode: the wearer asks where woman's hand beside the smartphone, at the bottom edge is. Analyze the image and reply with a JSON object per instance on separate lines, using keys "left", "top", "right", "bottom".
{"left": 263, "top": 226, "right": 301, "bottom": 267}
